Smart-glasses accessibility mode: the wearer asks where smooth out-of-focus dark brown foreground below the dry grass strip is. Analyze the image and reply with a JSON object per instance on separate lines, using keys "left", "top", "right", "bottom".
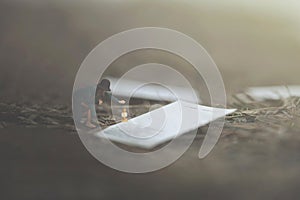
{"left": 0, "top": 127, "right": 300, "bottom": 199}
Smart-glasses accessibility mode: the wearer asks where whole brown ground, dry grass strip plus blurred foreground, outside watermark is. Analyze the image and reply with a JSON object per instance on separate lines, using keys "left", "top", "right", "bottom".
{"left": 0, "top": 98, "right": 300, "bottom": 199}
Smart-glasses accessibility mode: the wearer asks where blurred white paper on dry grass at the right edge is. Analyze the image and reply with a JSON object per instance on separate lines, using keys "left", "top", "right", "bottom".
{"left": 246, "top": 85, "right": 300, "bottom": 101}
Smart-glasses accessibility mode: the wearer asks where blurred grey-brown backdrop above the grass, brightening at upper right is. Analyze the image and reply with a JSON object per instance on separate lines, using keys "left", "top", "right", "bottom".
{"left": 0, "top": 0, "right": 300, "bottom": 103}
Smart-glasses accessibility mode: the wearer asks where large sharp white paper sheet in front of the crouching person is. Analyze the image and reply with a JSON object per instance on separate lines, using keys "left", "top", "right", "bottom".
{"left": 95, "top": 101, "right": 235, "bottom": 149}
